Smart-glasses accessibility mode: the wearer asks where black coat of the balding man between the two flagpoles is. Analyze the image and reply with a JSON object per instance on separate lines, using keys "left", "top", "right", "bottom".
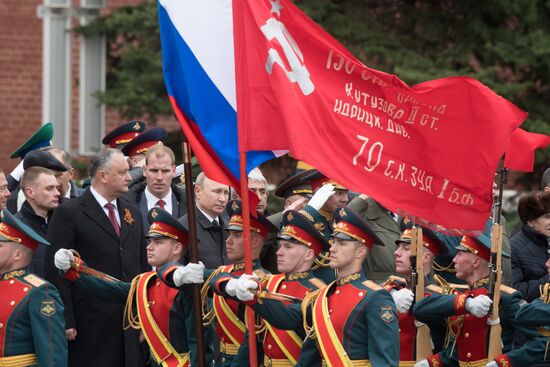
{"left": 179, "top": 208, "right": 228, "bottom": 269}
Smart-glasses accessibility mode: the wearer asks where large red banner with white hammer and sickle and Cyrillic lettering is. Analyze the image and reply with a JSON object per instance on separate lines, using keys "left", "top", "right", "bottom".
{"left": 233, "top": 0, "right": 527, "bottom": 230}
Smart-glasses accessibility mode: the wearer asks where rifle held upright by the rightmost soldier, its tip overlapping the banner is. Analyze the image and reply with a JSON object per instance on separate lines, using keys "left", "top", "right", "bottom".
{"left": 487, "top": 168, "right": 508, "bottom": 361}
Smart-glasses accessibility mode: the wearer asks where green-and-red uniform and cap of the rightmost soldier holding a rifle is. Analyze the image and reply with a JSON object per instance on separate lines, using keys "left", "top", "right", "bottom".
{"left": 413, "top": 234, "right": 544, "bottom": 366}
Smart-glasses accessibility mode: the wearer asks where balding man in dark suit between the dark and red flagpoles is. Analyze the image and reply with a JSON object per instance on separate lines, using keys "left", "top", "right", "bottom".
{"left": 179, "top": 172, "right": 229, "bottom": 269}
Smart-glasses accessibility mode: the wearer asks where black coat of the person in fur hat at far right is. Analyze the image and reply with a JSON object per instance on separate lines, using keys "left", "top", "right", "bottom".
{"left": 510, "top": 223, "right": 550, "bottom": 302}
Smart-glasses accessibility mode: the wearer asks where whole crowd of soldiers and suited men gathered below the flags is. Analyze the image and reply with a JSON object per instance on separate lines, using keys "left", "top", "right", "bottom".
{"left": 0, "top": 121, "right": 550, "bottom": 367}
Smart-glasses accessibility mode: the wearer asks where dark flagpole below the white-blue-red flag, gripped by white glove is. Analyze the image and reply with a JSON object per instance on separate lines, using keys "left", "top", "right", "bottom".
{"left": 182, "top": 131, "right": 206, "bottom": 367}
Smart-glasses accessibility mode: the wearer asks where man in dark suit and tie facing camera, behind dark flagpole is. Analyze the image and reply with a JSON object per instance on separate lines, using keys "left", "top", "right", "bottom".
{"left": 124, "top": 144, "right": 187, "bottom": 230}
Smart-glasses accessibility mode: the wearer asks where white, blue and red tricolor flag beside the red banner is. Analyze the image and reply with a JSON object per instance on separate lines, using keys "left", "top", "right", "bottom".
{"left": 158, "top": 0, "right": 286, "bottom": 189}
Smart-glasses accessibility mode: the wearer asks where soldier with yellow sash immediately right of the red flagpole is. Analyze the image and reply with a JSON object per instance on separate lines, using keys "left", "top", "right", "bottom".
{"left": 231, "top": 210, "right": 328, "bottom": 367}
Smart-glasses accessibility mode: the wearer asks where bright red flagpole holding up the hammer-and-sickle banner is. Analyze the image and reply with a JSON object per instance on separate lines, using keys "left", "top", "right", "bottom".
{"left": 239, "top": 152, "right": 258, "bottom": 367}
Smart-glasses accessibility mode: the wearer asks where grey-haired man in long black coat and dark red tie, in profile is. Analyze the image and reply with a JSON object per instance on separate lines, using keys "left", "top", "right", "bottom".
{"left": 45, "top": 148, "right": 149, "bottom": 367}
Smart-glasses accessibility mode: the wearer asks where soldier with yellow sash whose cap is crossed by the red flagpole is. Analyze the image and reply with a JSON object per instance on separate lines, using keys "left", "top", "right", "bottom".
{"left": 161, "top": 200, "right": 277, "bottom": 366}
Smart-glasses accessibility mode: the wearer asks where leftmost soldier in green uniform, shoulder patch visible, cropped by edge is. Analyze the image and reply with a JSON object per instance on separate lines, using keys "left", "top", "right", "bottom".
{"left": 0, "top": 209, "right": 67, "bottom": 367}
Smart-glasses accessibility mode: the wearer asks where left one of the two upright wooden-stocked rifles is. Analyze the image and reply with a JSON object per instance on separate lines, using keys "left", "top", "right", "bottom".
{"left": 410, "top": 226, "right": 432, "bottom": 361}
